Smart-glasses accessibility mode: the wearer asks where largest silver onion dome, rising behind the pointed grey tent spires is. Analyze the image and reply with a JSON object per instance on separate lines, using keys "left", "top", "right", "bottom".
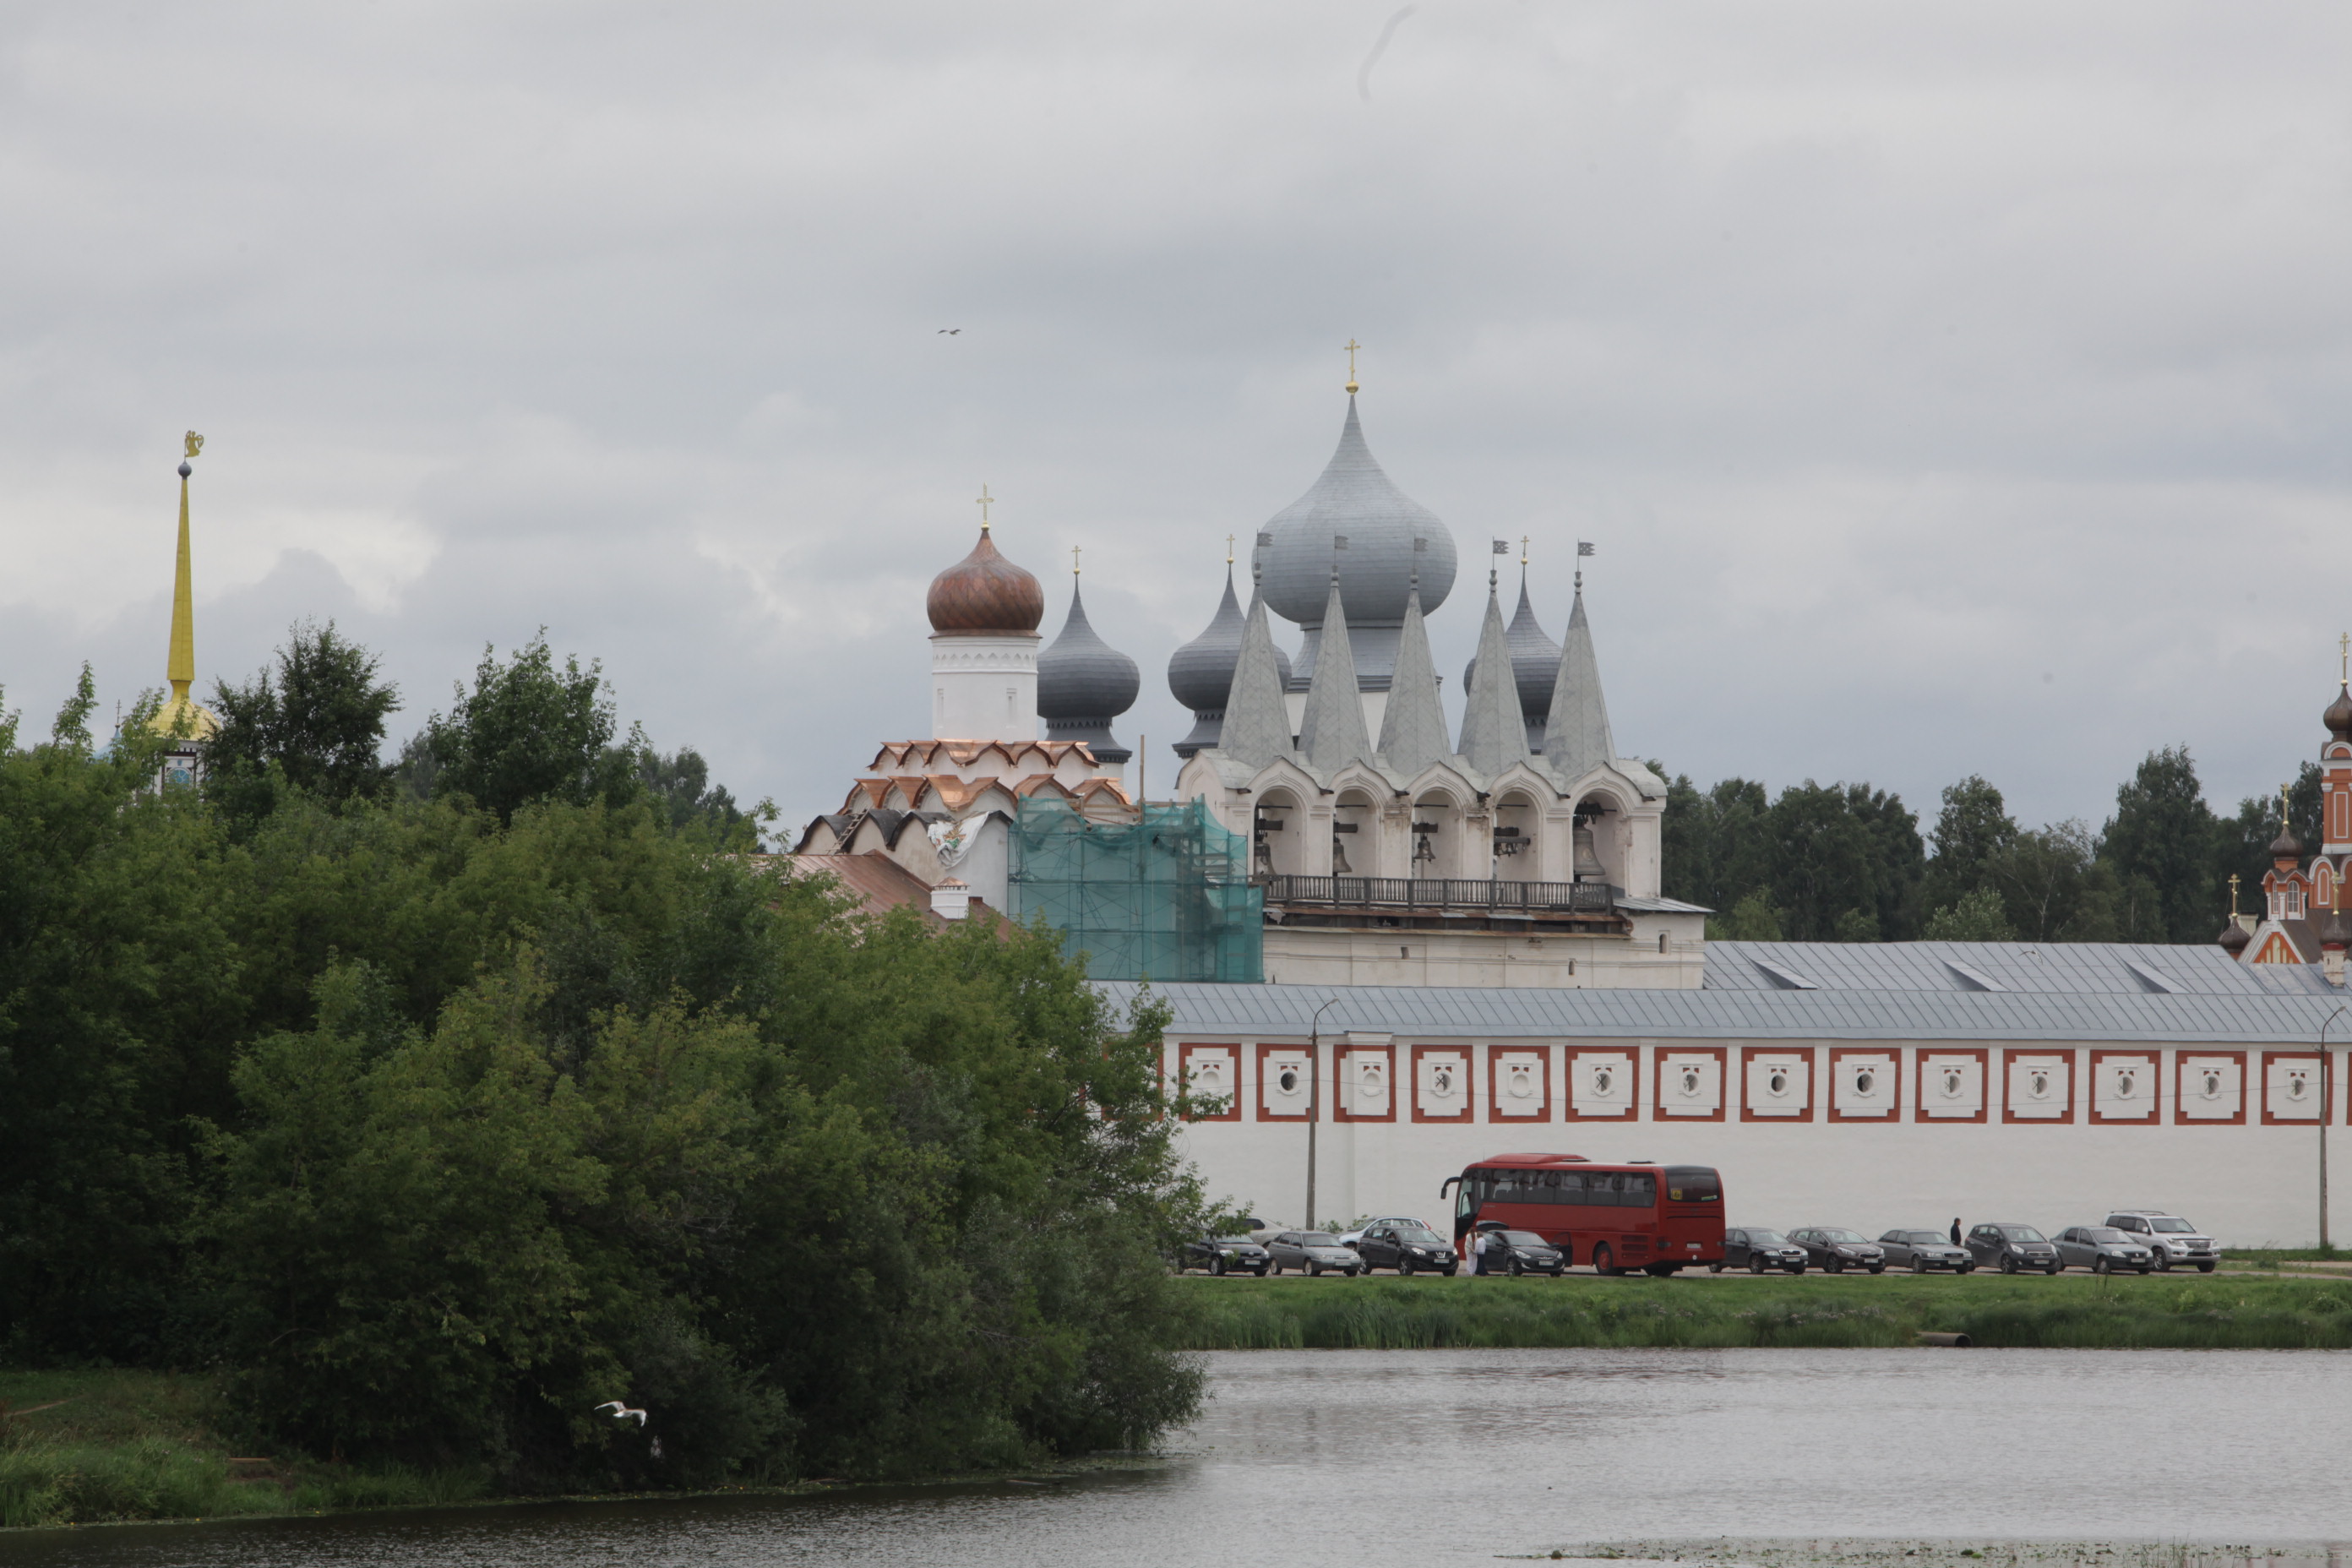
{"left": 1251, "top": 395, "right": 1454, "bottom": 691}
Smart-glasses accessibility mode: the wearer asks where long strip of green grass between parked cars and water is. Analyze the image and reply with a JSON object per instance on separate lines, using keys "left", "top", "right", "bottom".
{"left": 1185, "top": 1274, "right": 2352, "bottom": 1349}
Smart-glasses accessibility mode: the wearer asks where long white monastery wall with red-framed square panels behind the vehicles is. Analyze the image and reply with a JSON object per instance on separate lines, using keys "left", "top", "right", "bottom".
{"left": 1164, "top": 1034, "right": 2352, "bottom": 1246}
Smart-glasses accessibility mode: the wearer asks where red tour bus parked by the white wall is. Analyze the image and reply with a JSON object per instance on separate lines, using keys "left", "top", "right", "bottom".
{"left": 1437, "top": 1154, "right": 1724, "bottom": 1277}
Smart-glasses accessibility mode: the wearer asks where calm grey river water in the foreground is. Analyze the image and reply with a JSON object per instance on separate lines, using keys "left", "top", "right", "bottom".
{"left": 0, "top": 1349, "right": 2352, "bottom": 1568}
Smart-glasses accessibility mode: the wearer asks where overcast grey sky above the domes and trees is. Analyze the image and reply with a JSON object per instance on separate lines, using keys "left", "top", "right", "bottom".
{"left": 0, "top": 0, "right": 2352, "bottom": 841}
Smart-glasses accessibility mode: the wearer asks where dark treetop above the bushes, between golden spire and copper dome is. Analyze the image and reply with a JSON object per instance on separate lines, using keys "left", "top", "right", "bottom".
{"left": 426, "top": 628, "right": 637, "bottom": 823}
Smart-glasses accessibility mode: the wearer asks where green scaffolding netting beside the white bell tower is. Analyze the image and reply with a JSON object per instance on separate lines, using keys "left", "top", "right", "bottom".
{"left": 1011, "top": 799, "right": 1266, "bottom": 985}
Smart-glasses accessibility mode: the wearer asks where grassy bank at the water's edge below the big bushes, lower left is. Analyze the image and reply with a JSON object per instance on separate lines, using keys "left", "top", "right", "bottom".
{"left": 0, "top": 1370, "right": 487, "bottom": 1528}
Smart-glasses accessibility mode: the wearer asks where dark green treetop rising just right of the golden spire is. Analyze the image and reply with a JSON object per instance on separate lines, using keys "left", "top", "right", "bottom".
{"left": 204, "top": 621, "right": 400, "bottom": 820}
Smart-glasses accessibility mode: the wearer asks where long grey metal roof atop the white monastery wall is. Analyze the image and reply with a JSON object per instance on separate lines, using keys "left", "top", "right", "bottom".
{"left": 1098, "top": 943, "right": 2345, "bottom": 1043}
